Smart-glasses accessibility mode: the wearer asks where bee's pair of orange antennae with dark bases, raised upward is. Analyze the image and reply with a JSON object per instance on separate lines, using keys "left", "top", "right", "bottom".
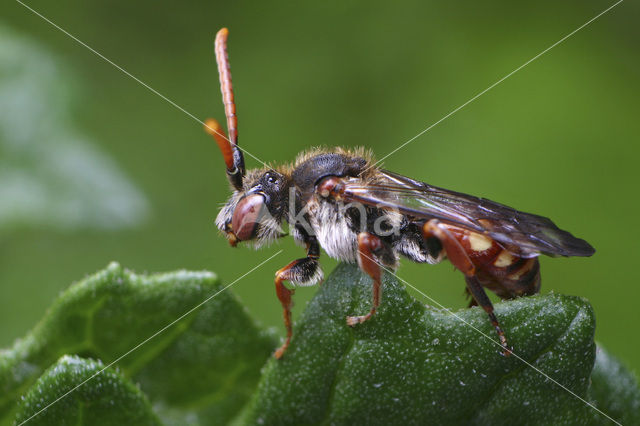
{"left": 205, "top": 28, "right": 245, "bottom": 190}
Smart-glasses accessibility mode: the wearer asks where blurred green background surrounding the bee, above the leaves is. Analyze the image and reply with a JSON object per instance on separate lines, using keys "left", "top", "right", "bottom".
{"left": 0, "top": 0, "right": 640, "bottom": 378}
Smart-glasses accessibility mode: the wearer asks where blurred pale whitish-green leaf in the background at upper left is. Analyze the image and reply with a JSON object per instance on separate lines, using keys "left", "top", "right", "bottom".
{"left": 0, "top": 23, "right": 150, "bottom": 233}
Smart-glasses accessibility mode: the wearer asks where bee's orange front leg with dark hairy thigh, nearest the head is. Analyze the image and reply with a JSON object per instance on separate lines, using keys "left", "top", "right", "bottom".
{"left": 274, "top": 238, "right": 323, "bottom": 359}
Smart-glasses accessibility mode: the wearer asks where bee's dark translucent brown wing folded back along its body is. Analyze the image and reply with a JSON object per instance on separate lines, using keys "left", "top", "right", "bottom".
{"left": 345, "top": 170, "right": 595, "bottom": 257}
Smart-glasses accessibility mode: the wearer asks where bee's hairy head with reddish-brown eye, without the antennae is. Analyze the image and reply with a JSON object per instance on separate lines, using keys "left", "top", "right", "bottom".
{"left": 216, "top": 169, "right": 289, "bottom": 248}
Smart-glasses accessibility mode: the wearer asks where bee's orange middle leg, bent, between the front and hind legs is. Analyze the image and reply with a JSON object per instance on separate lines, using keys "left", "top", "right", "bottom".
{"left": 347, "top": 232, "right": 396, "bottom": 327}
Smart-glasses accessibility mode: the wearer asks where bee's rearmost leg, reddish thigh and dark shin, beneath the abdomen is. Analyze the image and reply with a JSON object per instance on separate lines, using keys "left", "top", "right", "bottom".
{"left": 422, "top": 219, "right": 511, "bottom": 356}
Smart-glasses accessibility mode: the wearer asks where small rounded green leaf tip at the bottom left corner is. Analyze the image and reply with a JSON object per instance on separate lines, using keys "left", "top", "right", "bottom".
{"left": 16, "top": 356, "right": 160, "bottom": 426}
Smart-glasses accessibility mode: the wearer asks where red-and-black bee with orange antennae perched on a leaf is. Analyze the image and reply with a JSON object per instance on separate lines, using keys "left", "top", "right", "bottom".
{"left": 205, "top": 28, "right": 595, "bottom": 358}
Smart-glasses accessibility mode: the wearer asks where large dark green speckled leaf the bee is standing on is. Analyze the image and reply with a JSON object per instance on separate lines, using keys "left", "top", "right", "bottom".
{"left": 236, "top": 265, "right": 636, "bottom": 424}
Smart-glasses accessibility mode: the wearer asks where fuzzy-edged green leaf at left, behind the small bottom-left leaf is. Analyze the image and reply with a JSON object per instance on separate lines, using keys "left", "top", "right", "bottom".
{"left": 0, "top": 263, "right": 275, "bottom": 424}
